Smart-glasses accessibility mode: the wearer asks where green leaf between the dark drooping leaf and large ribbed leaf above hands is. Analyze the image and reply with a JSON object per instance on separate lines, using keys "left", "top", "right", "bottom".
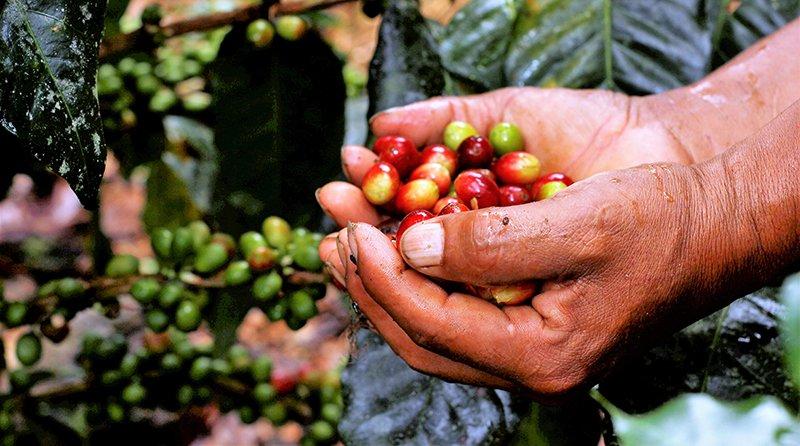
{"left": 439, "top": 0, "right": 519, "bottom": 89}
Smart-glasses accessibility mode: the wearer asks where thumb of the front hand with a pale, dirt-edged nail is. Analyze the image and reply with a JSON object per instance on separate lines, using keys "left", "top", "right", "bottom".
{"left": 400, "top": 200, "right": 582, "bottom": 285}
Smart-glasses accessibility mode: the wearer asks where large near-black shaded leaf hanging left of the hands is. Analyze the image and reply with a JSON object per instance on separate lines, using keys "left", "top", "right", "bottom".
{"left": 210, "top": 28, "right": 345, "bottom": 233}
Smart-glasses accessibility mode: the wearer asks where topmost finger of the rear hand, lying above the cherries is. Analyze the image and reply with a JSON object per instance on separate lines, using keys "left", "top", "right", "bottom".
{"left": 370, "top": 89, "right": 514, "bottom": 146}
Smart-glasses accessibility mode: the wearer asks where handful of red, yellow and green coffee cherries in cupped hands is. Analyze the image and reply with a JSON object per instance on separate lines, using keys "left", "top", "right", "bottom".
{"left": 361, "top": 121, "right": 573, "bottom": 305}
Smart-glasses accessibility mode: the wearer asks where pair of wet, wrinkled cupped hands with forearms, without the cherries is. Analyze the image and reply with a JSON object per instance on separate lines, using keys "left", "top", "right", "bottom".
{"left": 317, "top": 23, "right": 800, "bottom": 401}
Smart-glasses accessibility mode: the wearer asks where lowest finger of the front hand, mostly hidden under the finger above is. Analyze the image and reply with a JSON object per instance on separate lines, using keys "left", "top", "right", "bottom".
{"left": 334, "top": 229, "right": 517, "bottom": 390}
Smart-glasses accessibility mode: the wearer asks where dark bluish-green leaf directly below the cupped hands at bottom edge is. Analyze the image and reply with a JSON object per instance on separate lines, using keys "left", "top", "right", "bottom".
{"left": 339, "top": 329, "right": 519, "bottom": 445}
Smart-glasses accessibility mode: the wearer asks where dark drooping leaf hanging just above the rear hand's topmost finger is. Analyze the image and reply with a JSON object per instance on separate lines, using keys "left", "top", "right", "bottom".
{"left": 367, "top": 0, "right": 445, "bottom": 116}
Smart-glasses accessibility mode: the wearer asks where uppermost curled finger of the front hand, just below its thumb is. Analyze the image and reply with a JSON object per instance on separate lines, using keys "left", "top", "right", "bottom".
{"left": 348, "top": 224, "right": 544, "bottom": 382}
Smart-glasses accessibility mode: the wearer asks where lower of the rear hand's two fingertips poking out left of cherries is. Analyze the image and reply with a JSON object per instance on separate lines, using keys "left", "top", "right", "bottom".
{"left": 316, "top": 181, "right": 381, "bottom": 227}
